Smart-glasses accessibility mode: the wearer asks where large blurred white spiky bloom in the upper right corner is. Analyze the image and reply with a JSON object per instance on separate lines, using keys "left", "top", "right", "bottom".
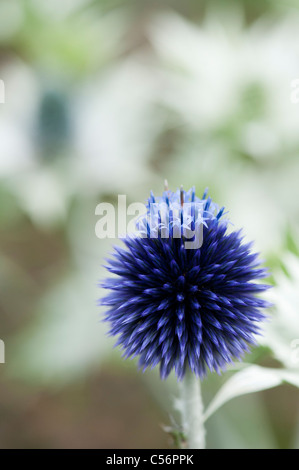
{"left": 149, "top": 11, "right": 299, "bottom": 159}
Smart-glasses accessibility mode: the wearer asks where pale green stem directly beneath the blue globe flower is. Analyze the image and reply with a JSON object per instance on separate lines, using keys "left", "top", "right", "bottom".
{"left": 180, "top": 368, "right": 205, "bottom": 449}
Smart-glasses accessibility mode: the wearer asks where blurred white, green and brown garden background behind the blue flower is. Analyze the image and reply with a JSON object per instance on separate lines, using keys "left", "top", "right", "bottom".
{"left": 0, "top": 0, "right": 299, "bottom": 449}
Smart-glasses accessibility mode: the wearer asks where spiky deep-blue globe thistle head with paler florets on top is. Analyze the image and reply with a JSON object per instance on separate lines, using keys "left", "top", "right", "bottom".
{"left": 100, "top": 185, "right": 269, "bottom": 379}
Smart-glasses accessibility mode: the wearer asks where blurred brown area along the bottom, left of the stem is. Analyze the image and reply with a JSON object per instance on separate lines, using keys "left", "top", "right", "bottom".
{"left": 0, "top": 367, "right": 169, "bottom": 449}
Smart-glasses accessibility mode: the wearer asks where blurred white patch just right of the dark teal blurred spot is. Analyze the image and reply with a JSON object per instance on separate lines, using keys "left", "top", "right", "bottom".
{"left": 74, "top": 56, "right": 163, "bottom": 193}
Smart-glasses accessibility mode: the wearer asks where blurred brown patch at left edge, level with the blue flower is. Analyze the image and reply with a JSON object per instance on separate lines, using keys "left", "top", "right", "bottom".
{"left": 0, "top": 216, "right": 68, "bottom": 334}
